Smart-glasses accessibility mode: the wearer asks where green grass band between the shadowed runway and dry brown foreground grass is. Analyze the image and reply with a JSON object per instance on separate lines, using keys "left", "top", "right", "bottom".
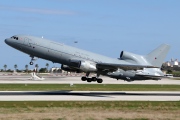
{"left": 0, "top": 101, "right": 180, "bottom": 110}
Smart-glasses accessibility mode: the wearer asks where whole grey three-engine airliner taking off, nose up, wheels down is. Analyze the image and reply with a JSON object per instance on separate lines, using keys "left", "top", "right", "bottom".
{"left": 5, "top": 35, "right": 170, "bottom": 83}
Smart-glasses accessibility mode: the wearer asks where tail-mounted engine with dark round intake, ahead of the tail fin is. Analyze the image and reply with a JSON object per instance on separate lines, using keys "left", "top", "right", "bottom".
{"left": 120, "top": 51, "right": 149, "bottom": 65}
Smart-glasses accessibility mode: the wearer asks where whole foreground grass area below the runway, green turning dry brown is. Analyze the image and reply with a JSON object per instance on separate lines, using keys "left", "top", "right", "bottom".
{"left": 0, "top": 101, "right": 180, "bottom": 120}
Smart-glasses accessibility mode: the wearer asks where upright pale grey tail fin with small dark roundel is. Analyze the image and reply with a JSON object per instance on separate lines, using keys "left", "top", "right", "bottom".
{"left": 145, "top": 44, "right": 170, "bottom": 67}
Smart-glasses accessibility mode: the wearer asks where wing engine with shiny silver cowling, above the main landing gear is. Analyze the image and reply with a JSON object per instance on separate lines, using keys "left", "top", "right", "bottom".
{"left": 69, "top": 59, "right": 97, "bottom": 72}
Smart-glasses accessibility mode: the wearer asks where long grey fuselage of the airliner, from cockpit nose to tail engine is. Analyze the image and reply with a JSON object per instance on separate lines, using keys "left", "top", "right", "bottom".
{"left": 5, "top": 35, "right": 138, "bottom": 65}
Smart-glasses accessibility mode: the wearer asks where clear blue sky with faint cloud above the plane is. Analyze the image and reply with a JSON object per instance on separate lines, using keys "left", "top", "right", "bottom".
{"left": 0, "top": 0, "right": 180, "bottom": 69}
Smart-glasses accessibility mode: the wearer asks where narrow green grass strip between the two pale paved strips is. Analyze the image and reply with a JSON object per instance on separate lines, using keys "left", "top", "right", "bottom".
{"left": 0, "top": 84, "right": 180, "bottom": 91}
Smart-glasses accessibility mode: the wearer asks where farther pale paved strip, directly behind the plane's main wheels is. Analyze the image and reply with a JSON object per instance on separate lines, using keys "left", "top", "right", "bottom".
{"left": 0, "top": 75, "right": 180, "bottom": 85}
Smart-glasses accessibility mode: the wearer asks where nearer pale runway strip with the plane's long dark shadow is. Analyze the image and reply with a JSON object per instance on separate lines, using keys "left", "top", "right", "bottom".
{"left": 0, "top": 91, "right": 180, "bottom": 101}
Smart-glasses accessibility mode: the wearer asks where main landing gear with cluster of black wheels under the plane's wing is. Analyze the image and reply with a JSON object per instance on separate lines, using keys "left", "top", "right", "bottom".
{"left": 81, "top": 73, "right": 103, "bottom": 83}
